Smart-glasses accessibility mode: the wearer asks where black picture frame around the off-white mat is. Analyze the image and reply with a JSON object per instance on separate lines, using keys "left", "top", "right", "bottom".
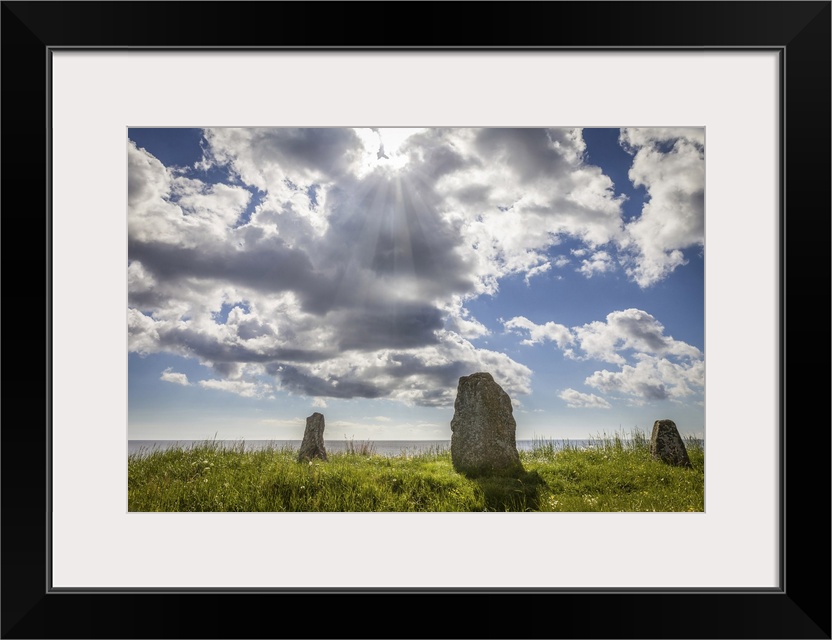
{"left": 0, "top": 1, "right": 832, "bottom": 638}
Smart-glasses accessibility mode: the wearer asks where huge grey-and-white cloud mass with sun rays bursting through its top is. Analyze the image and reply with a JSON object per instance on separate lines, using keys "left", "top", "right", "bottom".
{"left": 127, "top": 128, "right": 694, "bottom": 406}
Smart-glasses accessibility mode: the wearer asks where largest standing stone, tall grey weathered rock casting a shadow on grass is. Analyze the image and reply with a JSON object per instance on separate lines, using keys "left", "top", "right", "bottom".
{"left": 451, "top": 372, "right": 523, "bottom": 475}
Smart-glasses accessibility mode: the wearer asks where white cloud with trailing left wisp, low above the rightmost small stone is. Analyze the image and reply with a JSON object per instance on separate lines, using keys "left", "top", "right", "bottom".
{"left": 503, "top": 309, "right": 705, "bottom": 406}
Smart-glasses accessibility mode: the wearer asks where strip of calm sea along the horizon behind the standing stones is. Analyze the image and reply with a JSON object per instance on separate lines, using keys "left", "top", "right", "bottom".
{"left": 127, "top": 440, "right": 591, "bottom": 457}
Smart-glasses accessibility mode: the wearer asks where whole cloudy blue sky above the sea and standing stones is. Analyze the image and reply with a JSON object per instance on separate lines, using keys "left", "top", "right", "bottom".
{"left": 127, "top": 128, "right": 705, "bottom": 440}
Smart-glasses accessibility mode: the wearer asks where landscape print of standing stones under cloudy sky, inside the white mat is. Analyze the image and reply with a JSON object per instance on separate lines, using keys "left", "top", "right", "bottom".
{"left": 125, "top": 126, "right": 706, "bottom": 513}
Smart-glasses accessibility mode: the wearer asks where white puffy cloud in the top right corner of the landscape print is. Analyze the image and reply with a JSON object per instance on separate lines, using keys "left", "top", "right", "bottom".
{"left": 619, "top": 128, "right": 705, "bottom": 287}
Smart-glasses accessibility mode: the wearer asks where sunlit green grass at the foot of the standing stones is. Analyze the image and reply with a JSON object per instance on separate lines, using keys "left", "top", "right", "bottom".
{"left": 128, "top": 430, "right": 705, "bottom": 512}
